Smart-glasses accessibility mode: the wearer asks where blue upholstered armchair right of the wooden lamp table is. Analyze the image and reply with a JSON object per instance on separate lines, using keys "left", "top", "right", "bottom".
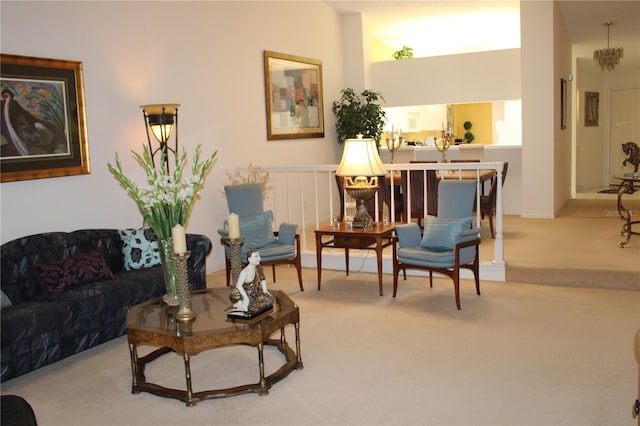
{"left": 393, "top": 179, "right": 480, "bottom": 309}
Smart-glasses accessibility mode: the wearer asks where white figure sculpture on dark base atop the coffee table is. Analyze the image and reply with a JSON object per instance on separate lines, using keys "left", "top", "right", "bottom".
{"left": 227, "top": 250, "right": 273, "bottom": 319}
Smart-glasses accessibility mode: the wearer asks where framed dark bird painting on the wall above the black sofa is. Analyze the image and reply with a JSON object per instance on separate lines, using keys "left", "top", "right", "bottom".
{"left": 0, "top": 54, "right": 91, "bottom": 182}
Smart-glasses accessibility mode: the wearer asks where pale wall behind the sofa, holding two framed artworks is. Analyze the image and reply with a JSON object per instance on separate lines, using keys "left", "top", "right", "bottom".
{"left": 0, "top": 0, "right": 343, "bottom": 270}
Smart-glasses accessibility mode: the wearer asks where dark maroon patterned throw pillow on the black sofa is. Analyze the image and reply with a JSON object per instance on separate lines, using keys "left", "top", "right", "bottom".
{"left": 34, "top": 249, "right": 114, "bottom": 294}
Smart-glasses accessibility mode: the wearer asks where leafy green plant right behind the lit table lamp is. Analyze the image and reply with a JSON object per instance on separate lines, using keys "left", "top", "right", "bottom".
{"left": 331, "top": 88, "right": 386, "bottom": 148}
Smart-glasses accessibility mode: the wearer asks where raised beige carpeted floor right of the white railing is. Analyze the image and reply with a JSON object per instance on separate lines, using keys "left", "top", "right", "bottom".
{"left": 502, "top": 200, "right": 640, "bottom": 290}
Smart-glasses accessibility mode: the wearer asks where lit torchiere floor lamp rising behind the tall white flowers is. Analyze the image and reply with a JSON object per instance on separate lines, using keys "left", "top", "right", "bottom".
{"left": 140, "top": 104, "right": 180, "bottom": 173}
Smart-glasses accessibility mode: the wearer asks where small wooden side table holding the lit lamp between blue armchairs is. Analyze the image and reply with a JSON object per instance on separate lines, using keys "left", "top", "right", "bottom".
{"left": 315, "top": 222, "right": 394, "bottom": 296}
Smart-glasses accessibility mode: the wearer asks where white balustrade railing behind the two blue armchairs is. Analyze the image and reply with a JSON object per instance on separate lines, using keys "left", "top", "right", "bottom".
{"left": 240, "top": 162, "right": 506, "bottom": 281}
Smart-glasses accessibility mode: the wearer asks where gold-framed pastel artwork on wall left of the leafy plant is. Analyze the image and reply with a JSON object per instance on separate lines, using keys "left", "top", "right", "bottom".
{"left": 264, "top": 50, "right": 324, "bottom": 140}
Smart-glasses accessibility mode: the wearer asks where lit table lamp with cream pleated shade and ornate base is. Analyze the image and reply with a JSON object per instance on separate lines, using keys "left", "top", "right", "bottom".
{"left": 336, "top": 135, "right": 386, "bottom": 228}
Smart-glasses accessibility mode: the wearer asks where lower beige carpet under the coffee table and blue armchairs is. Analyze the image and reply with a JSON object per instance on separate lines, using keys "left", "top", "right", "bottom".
{"left": 2, "top": 267, "right": 640, "bottom": 426}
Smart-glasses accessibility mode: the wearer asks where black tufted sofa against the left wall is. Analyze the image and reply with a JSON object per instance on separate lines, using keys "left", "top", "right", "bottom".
{"left": 0, "top": 229, "right": 211, "bottom": 382}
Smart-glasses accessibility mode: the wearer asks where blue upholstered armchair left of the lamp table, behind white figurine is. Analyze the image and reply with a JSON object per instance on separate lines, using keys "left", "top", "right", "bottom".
{"left": 218, "top": 183, "right": 304, "bottom": 291}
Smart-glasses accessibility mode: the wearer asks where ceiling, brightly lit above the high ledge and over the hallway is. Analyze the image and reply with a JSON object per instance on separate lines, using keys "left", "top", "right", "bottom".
{"left": 326, "top": 0, "right": 640, "bottom": 72}
